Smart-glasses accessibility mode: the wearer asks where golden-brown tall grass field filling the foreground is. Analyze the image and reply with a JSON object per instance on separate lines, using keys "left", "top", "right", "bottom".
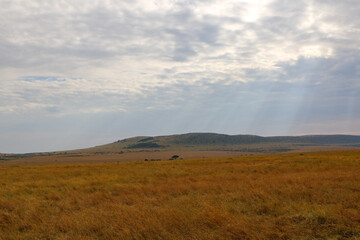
{"left": 0, "top": 151, "right": 360, "bottom": 239}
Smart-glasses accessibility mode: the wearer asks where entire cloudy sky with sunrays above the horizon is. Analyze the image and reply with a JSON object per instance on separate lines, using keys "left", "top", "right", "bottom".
{"left": 0, "top": 0, "right": 360, "bottom": 153}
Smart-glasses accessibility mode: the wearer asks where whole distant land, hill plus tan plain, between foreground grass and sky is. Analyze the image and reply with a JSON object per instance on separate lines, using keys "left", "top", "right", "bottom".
{"left": 0, "top": 133, "right": 360, "bottom": 164}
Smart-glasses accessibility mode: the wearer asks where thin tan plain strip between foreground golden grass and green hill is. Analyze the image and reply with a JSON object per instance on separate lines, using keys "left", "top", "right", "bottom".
{"left": 0, "top": 144, "right": 354, "bottom": 167}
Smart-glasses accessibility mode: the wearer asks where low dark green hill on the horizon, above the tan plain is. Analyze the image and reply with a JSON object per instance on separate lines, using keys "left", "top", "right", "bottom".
{"left": 88, "top": 133, "right": 360, "bottom": 152}
